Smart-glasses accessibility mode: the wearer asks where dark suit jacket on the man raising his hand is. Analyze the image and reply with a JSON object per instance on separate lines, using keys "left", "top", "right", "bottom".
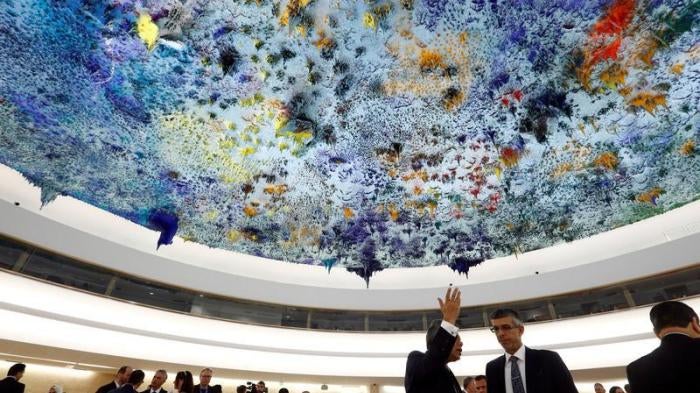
{"left": 402, "top": 328, "right": 462, "bottom": 393}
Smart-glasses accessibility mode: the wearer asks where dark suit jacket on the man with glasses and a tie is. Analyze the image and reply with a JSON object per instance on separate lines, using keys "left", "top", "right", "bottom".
{"left": 486, "top": 347, "right": 576, "bottom": 393}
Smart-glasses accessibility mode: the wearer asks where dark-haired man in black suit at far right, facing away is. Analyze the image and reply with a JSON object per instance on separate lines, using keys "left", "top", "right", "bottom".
{"left": 627, "top": 301, "right": 700, "bottom": 393}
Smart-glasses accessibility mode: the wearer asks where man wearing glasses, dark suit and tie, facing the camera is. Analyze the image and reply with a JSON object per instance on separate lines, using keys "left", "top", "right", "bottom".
{"left": 486, "top": 309, "right": 578, "bottom": 393}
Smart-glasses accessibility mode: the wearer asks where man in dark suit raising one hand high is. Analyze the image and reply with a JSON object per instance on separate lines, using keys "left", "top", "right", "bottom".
{"left": 404, "top": 287, "right": 462, "bottom": 393}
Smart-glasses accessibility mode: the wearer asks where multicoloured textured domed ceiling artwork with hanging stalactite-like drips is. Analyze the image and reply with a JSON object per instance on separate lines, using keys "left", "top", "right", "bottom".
{"left": 0, "top": 0, "right": 700, "bottom": 283}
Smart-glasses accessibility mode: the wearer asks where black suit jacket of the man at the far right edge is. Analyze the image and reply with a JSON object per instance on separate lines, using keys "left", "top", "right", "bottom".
{"left": 627, "top": 334, "right": 700, "bottom": 393}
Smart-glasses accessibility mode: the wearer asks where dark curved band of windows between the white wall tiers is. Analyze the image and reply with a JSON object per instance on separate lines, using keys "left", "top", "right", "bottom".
{"left": 0, "top": 236, "right": 700, "bottom": 332}
